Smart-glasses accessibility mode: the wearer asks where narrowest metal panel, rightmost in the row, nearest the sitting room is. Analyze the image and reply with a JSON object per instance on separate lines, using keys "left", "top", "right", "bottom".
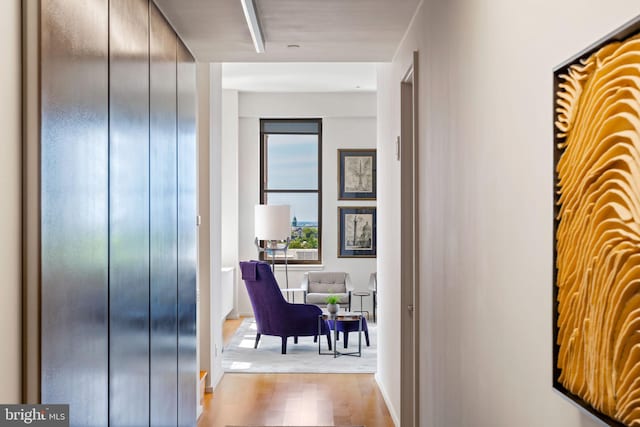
{"left": 177, "top": 43, "right": 198, "bottom": 427}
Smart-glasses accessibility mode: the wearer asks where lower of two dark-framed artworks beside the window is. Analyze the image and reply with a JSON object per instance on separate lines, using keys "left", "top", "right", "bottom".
{"left": 338, "top": 206, "right": 376, "bottom": 258}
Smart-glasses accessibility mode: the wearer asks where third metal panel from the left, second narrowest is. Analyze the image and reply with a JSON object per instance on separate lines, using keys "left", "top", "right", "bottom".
{"left": 149, "top": 4, "right": 178, "bottom": 427}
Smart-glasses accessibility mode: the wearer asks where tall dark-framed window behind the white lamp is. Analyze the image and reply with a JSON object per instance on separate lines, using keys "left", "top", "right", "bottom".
{"left": 260, "top": 119, "right": 322, "bottom": 264}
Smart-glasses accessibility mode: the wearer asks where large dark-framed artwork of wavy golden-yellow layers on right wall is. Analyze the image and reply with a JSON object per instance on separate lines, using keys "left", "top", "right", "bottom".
{"left": 554, "top": 19, "right": 640, "bottom": 426}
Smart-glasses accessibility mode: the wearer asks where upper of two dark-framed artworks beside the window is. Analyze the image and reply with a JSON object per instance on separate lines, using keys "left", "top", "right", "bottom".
{"left": 338, "top": 149, "right": 376, "bottom": 200}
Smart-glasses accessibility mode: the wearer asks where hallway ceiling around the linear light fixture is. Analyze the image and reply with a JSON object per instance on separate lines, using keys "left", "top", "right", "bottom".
{"left": 155, "top": 0, "right": 420, "bottom": 62}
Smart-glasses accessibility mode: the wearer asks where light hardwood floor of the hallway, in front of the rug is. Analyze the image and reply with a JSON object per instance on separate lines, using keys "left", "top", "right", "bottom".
{"left": 198, "top": 319, "right": 394, "bottom": 427}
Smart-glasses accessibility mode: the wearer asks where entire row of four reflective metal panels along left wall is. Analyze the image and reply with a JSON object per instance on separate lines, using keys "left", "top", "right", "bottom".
{"left": 40, "top": 0, "right": 198, "bottom": 427}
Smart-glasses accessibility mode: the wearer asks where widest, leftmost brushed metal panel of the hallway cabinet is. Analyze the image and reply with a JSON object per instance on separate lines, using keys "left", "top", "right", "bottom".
{"left": 40, "top": 0, "right": 108, "bottom": 427}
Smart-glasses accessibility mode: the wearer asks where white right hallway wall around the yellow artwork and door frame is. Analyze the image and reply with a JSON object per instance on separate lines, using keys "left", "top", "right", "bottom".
{"left": 378, "top": 0, "right": 640, "bottom": 427}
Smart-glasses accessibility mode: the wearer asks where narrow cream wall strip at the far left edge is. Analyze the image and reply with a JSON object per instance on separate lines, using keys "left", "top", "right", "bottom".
{"left": 0, "top": 0, "right": 22, "bottom": 403}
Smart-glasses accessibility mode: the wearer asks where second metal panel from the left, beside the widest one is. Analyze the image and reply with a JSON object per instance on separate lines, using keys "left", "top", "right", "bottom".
{"left": 109, "top": 0, "right": 149, "bottom": 427}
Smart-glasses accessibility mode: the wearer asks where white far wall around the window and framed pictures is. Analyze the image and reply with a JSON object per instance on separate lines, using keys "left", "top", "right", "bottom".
{"left": 231, "top": 93, "right": 379, "bottom": 315}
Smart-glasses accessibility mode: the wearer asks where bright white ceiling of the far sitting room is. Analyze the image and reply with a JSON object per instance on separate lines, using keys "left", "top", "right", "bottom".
{"left": 222, "top": 62, "right": 376, "bottom": 92}
